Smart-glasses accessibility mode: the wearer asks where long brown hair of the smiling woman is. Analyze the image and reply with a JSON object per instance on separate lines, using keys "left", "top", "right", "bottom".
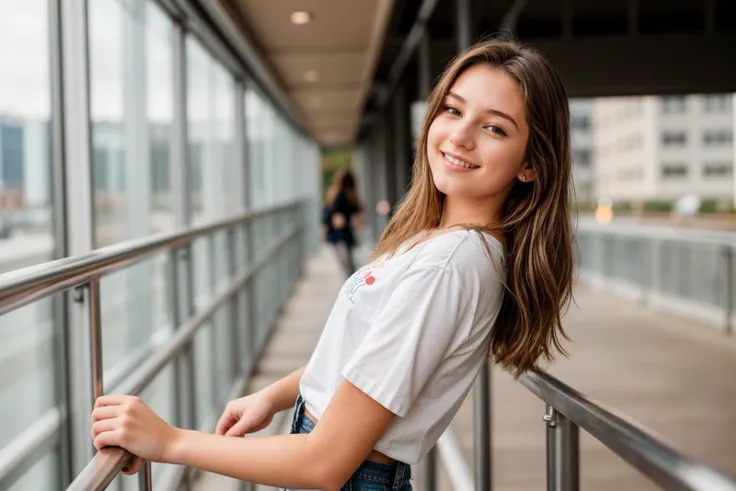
{"left": 375, "top": 40, "right": 573, "bottom": 376}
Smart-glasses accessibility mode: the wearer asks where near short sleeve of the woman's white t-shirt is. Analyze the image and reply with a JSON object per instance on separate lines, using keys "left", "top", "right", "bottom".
{"left": 342, "top": 266, "right": 468, "bottom": 417}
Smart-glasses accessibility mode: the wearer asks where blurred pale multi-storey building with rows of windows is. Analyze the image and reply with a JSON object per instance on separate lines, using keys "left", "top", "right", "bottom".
{"left": 592, "top": 94, "right": 734, "bottom": 203}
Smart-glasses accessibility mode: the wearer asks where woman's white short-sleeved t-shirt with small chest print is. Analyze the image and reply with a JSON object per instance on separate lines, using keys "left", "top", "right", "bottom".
{"left": 300, "top": 230, "right": 506, "bottom": 464}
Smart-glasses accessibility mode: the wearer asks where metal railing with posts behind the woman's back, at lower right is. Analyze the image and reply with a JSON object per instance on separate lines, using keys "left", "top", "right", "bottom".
{"left": 432, "top": 367, "right": 736, "bottom": 491}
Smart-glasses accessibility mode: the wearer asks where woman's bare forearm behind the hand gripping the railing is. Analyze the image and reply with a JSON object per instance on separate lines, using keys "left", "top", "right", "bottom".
{"left": 166, "top": 430, "right": 340, "bottom": 489}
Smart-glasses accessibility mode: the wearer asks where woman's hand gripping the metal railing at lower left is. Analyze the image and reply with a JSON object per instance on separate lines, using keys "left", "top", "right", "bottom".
{"left": 92, "top": 395, "right": 180, "bottom": 462}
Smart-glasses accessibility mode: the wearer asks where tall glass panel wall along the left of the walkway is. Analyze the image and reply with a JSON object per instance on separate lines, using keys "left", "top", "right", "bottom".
{"left": 0, "top": 0, "right": 320, "bottom": 491}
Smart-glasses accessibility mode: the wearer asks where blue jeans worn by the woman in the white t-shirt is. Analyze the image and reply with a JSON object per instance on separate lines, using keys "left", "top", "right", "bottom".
{"left": 291, "top": 395, "right": 412, "bottom": 491}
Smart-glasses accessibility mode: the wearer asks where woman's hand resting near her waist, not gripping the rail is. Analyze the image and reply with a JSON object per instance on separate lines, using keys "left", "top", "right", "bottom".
{"left": 216, "top": 392, "right": 274, "bottom": 437}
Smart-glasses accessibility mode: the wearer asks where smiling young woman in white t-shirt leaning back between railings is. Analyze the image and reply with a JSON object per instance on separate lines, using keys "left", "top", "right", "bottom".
{"left": 92, "top": 41, "right": 573, "bottom": 490}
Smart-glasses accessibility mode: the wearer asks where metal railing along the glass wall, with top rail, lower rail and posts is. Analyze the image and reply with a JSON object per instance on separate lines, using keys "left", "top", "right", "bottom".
{"left": 0, "top": 200, "right": 303, "bottom": 490}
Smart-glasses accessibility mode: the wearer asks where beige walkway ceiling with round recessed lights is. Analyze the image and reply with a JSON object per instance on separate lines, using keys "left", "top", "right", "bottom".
{"left": 229, "top": 0, "right": 394, "bottom": 146}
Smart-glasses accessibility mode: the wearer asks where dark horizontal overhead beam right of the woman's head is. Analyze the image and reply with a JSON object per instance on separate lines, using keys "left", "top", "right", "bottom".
{"left": 432, "top": 33, "right": 736, "bottom": 97}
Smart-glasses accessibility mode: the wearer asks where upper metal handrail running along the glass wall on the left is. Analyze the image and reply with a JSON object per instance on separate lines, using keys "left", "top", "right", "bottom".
{"left": 0, "top": 201, "right": 301, "bottom": 315}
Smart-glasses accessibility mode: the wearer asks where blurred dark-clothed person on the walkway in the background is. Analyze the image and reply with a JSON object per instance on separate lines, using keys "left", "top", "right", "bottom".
{"left": 322, "top": 169, "right": 362, "bottom": 277}
